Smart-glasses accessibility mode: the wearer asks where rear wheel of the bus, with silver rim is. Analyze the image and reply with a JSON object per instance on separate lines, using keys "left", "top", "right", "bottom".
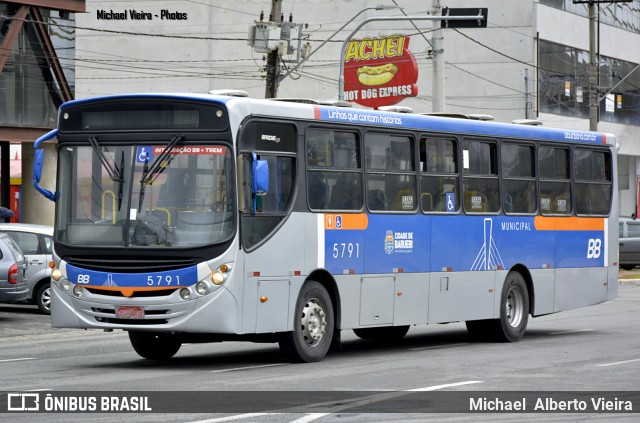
{"left": 466, "top": 272, "right": 529, "bottom": 342}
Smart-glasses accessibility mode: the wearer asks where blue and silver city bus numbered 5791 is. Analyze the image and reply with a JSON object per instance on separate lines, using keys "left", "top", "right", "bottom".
{"left": 34, "top": 94, "right": 618, "bottom": 362}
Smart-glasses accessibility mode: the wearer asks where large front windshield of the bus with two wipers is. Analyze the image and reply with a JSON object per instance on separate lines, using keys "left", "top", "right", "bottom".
{"left": 56, "top": 142, "right": 235, "bottom": 248}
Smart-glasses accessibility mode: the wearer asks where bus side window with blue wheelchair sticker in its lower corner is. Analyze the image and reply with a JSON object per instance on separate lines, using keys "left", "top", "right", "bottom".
{"left": 420, "top": 138, "right": 460, "bottom": 213}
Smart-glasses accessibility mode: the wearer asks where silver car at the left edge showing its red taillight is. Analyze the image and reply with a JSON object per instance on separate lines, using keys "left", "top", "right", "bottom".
{"left": 0, "top": 233, "right": 29, "bottom": 303}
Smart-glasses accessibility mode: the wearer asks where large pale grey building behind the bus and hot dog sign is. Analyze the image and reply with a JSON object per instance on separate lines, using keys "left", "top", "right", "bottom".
{"left": 10, "top": 0, "right": 640, "bottom": 222}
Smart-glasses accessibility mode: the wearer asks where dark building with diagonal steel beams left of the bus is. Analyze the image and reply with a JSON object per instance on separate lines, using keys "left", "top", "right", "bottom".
{"left": 0, "top": 0, "right": 85, "bottom": 224}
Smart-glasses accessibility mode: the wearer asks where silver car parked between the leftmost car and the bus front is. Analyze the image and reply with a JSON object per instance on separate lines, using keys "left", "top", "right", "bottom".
{"left": 0, "top": 223, "right": 53, "bottom": 314}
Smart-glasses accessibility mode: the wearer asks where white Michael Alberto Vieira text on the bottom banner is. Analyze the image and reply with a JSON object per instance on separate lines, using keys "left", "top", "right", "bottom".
{"left": 469, "top": 397, "right": 633, "bottom": 412}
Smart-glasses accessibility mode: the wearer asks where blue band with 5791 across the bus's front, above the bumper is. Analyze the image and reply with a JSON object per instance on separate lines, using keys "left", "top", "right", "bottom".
{"left": 66, "top": 264, "right": 198, "bottom": 288}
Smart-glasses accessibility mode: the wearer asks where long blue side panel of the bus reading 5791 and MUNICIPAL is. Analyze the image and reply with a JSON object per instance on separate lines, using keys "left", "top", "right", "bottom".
{"left": 325, "top": 214, "right": 605, "bottom": 274}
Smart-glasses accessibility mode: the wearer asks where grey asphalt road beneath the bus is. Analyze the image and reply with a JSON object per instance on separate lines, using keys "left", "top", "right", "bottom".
{"left": 0, "top": 280, "right": 640, "bottom": 423}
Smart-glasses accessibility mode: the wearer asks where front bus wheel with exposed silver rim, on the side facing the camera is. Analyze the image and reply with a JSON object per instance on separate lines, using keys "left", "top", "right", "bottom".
{"left": 278, "top": 281, "right": 335, "bottom": 363}
